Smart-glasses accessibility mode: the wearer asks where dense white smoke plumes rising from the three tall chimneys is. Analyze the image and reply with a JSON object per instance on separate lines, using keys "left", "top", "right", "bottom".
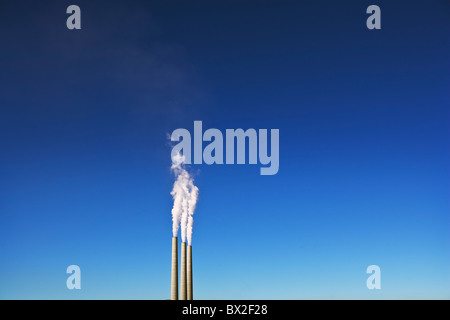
{"left": 170, "top": 153, "right": 198, "bottom": 245}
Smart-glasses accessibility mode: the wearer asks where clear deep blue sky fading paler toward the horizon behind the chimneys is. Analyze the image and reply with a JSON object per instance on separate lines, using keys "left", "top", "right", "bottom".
{"left": 0, "top": 0, "right": 450, "bottom": 299}
